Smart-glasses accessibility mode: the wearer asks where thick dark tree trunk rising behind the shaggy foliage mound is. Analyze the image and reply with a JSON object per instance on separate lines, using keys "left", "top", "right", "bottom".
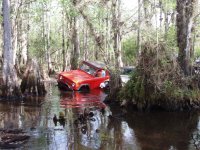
{"left": 176, "top": 0, "right": 197, "bottom": 75}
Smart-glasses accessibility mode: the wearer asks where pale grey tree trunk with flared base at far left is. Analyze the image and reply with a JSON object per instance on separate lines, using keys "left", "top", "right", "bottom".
{"left": 2, "top": 0, "right": 21, "bottom": 97}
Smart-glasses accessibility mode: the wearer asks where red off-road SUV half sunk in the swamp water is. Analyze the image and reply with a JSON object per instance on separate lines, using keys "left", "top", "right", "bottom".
{"left": 57, "top": 61, "right": 110, "bottom": 90}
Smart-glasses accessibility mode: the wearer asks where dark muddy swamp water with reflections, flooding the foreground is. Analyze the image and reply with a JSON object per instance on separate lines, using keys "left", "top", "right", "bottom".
{"left": 0, "top": 84, "right": 200, "bottom": 150}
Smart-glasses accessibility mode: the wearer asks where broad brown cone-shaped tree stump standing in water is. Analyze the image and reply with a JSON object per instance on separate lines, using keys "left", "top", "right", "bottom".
{"left": 21, "top": 60, "right": 46, "bottom": 95}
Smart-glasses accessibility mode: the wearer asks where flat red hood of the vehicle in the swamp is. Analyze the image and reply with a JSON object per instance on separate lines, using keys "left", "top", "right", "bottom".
{"left": 60, "top": 70, "right": 93, "bottom": 83}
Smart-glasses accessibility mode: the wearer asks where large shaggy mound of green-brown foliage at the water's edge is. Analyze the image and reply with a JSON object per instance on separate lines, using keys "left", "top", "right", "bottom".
{"left": 120, "top": 42, "right": 200, "bottom": 110}
